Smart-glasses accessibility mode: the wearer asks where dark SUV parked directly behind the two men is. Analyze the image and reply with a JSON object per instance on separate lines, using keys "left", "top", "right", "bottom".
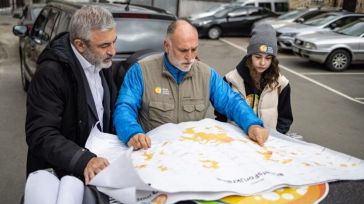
{"left": 13, "top": 1, "right": 176, "bottom": 90}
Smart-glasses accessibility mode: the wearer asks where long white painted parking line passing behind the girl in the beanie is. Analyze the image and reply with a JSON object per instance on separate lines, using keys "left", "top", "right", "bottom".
{"left": 220, "top": 38, "right": 364, "bottom": 105}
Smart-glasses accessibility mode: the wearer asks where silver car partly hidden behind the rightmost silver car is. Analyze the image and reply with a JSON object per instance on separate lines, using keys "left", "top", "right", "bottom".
{"left": 277, "top": 11, "right": 364, "bottom": 50}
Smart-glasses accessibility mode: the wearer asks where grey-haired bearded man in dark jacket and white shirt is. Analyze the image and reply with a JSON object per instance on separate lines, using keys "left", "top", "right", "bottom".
{"left": 26, "top": 6, "right": 117, "bottom": 183}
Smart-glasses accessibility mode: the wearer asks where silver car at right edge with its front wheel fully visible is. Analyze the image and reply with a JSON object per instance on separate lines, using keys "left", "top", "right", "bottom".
{"left": 292, "top": 17, "right": 364, "bottom": 72}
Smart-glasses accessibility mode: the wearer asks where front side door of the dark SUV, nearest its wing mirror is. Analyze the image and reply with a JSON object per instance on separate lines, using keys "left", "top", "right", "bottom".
{"left": 24, "top": 7, "right": 59, "bottom": 78}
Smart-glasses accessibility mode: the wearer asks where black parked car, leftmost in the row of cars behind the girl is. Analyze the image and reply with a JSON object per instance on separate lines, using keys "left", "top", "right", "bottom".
{"left": 188, "top": 4, "right": 278, "bottom": 39}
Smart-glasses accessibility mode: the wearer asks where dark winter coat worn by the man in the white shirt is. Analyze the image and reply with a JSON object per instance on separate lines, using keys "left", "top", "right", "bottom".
{"left": 25, "top": 33, "right": 117, "bottom": 178}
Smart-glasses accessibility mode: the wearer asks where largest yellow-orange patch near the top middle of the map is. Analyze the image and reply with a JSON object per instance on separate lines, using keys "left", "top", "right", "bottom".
{"left": 181, "top": 128, "right": 233, "bottom": 144}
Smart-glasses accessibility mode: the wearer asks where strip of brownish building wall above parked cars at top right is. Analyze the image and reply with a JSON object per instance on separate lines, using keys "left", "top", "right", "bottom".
{"left": 289, "top": 0, "right": 364, "bottom": 13}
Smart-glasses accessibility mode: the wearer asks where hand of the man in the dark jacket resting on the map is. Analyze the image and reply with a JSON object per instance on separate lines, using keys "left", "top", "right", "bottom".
{"left": 83, "top": 157, "right": 109, "bottom": 184}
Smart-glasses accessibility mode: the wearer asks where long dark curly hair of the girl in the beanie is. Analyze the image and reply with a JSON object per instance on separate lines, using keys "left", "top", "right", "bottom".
{"left": 246, "top": 55, "right": 279, "bottom": 89}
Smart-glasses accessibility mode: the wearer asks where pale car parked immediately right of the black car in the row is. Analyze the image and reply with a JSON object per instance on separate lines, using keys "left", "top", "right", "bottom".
{"left": 255, "top": 7, "right": 334, "bottom": 29}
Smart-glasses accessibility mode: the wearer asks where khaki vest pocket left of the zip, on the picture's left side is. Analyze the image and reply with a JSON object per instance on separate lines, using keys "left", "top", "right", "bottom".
{"left": 149, "top": 101, "right": 175, "bottom": 123}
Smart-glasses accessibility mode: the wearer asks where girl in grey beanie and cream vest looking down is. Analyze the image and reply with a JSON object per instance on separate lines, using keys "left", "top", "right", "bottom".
{"left": 215, "top": 24, "right": 293, "bottom": 134}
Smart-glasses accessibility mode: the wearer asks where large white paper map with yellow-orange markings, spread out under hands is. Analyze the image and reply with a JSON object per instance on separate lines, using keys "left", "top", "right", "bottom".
{"left": 88, "top": 119, "right": 364, "bottom": 203}
